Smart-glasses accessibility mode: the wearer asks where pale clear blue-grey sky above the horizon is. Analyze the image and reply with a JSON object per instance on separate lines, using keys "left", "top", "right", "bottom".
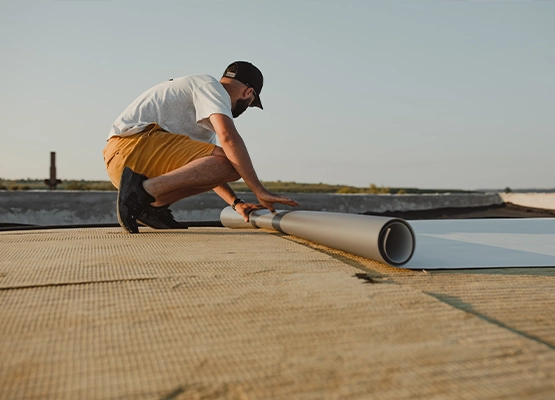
{"left": 0, "top": 0, "right": 555, "bottom": 190}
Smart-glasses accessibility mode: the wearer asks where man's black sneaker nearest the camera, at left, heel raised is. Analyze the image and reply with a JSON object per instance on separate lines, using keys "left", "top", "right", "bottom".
{"left": 117, "top": 167, "right": 155, "bottom": 233}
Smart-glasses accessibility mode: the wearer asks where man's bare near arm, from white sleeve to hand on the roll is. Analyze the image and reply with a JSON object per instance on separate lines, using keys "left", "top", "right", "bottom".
{"left": 210, "top": 114, "right": 299, "bottom": 211}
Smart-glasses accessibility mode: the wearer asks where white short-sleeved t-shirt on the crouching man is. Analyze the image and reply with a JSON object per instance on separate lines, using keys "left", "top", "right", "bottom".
{"left": 108, "top": 75, "right": 233, "bottom": 143}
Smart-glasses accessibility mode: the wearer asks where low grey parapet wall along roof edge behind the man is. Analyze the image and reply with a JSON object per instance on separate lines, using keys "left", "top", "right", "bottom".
{"left": 0, "top": 191, "right": 536, "bottom": 225}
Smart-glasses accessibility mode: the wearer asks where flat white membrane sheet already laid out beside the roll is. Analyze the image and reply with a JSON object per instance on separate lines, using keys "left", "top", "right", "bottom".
{"left": 403, "top": 218, "right": 555, "bottom": 269}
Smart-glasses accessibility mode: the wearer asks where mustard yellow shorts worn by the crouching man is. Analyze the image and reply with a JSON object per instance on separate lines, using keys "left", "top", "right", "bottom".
{"left": 103, "top": 124, "right": 216, "bottom": 188}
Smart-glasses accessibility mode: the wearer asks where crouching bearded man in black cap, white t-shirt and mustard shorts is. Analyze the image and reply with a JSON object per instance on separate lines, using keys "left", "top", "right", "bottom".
{"left": 104, "top": 61, "right": 298, "bottom": 233}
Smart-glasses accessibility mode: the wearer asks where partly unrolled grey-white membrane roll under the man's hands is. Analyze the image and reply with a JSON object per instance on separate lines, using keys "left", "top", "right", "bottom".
{"left": 220, "top": 207, "right": 416, "bottom": 267}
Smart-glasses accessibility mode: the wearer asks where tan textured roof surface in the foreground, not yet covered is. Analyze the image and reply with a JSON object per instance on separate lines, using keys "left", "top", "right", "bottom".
{"left": 0, "top": 228, "right": 555, "bottom": 399}
